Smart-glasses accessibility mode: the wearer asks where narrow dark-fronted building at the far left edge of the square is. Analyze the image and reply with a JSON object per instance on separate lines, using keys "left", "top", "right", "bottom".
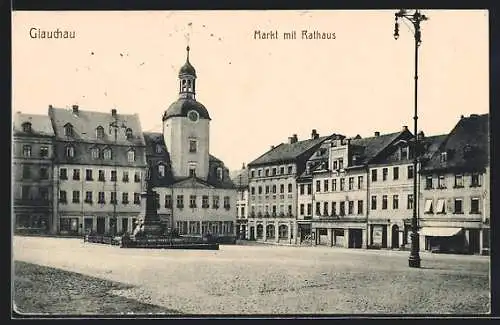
{"left": 12, "top": 112, "right": 54, "bottom": 233}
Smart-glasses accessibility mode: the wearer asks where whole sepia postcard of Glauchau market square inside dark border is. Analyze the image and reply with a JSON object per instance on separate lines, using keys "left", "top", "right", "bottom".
{"left": 11, "top": 8, "right": 491, "bottom": 318}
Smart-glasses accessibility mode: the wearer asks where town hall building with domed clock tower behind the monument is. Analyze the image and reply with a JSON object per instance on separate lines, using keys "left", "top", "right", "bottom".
{"left": 147, "top": 47, "right": 236, "bottom": 236}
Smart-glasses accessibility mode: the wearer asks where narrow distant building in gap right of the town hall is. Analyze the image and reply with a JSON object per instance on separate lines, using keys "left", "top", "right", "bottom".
{"left": 231, "top": 164, "right": 249, "bottom": 239}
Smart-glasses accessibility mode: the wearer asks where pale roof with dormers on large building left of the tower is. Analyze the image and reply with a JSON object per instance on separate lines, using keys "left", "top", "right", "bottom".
{"left": 49, "top": 106, "right": 145, "bottom": 146}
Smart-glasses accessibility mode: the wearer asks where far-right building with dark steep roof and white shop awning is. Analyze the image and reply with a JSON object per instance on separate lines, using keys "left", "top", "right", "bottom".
{"left": 419, "top": 114, "right": 490, "bottom": 253}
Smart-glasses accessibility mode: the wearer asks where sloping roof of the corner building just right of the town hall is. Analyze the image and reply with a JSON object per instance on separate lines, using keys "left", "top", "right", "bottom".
{"left": 248, "top": 136, "right": 330, "bottom": 166}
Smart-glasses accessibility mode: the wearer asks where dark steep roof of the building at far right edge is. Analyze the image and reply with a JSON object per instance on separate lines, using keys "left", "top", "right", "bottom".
{"left": 423, "top": 114, "right": 489, "bottom": 172}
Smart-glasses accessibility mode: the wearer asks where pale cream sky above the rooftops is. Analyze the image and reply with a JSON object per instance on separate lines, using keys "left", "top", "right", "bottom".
{"left": 12, "top": 10, "right": 489, "bottom": 170}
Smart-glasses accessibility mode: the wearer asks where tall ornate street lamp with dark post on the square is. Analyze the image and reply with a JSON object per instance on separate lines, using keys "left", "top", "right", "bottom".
{"left": 394, "top": 9, "right": 428, "bottom": 267}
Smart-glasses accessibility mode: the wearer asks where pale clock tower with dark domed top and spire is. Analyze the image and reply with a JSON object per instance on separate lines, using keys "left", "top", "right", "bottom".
{"left": 163, "top": 46, "right": 210, "bottom": 180}
